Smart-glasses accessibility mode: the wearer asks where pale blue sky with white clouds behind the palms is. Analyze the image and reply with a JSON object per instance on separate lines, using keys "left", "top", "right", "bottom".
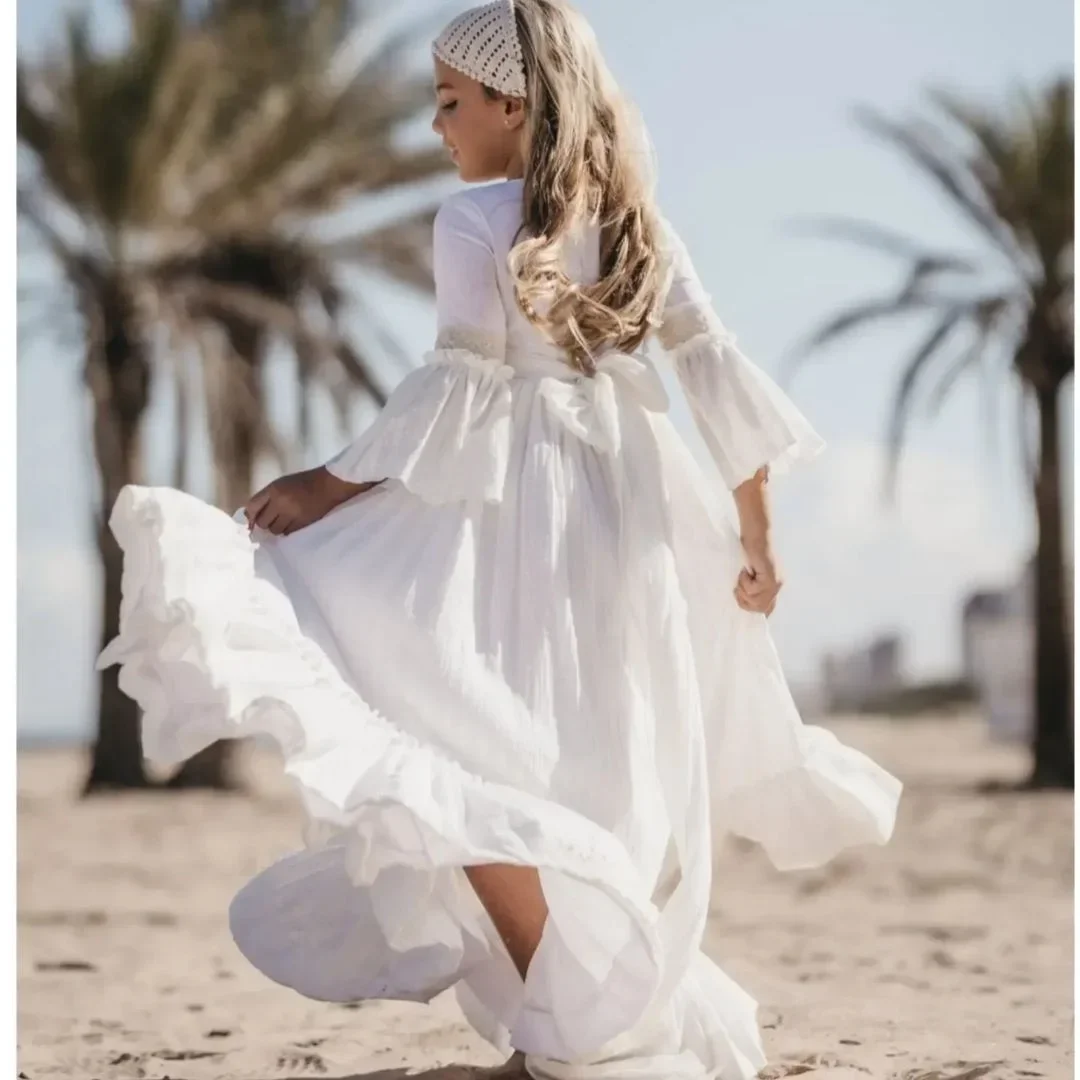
{"left": 17, "top": 0, "right": 1074, "bottom": 735}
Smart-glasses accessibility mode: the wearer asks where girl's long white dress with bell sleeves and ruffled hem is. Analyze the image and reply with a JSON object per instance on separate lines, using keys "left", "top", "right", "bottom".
{"left": 99, "top": 180, "right": 901, "bottom": 1080}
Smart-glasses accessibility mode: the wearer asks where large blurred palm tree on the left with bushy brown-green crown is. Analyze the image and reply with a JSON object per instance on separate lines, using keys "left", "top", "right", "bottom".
{"left": 17, "top": 0, "right": 448, "bottom": 791}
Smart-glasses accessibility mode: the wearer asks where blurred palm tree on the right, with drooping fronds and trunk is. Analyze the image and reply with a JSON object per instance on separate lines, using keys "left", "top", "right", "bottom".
{"left": 799, "top": 79, "right": 1075, "bottom": 788}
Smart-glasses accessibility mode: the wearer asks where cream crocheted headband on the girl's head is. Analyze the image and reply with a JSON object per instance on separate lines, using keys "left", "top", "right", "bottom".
{"left": 431, "top": 0, "right": 525, "bottom": 97}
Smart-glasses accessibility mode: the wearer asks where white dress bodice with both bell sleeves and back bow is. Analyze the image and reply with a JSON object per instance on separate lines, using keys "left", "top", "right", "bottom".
{"left": 327, "top": 180, "right": 823, "bottom": 500}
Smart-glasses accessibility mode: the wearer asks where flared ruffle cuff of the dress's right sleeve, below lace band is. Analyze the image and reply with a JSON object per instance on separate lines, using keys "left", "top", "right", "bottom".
{"left": 672, "top": 328, "right": 825, "bottom": 490}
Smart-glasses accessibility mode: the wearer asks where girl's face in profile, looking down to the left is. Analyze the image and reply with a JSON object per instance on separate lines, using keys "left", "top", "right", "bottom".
{"left": 431, "top": 57, "right": 525, "bottom": 183}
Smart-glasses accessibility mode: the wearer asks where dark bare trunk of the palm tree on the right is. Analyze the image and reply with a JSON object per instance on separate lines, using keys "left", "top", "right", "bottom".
{"left": 1028, "top": 383, "right": 1075, "bottom": 788}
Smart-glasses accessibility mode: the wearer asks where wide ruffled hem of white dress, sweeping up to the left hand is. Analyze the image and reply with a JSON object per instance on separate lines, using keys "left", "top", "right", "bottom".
{"left": 97, "top": 486, "right": 663, "bottom": 1059}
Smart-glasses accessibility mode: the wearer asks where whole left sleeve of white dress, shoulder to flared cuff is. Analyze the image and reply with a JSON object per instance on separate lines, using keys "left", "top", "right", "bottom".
{"left": 326, "top": 193, "right": 513, "bottom": 502}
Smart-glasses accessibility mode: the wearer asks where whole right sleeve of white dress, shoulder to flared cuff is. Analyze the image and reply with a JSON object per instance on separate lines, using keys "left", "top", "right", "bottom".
{"left": 658, "top": 221, "right": 825, "bottom": 490}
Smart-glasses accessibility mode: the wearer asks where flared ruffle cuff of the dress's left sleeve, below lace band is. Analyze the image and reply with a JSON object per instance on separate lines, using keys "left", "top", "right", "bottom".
{"left": 326, "top": 348, "right": 514, "bottom": 503}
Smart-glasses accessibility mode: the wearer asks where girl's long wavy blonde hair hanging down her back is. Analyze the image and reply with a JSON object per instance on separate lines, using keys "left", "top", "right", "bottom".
{"left": 498, "top": 0, "right": 661, "bottom": 375}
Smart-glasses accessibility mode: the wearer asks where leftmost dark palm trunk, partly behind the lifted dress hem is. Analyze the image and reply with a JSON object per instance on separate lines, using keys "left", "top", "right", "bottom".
{"left": 82, "top": 279, "right": 150, "bottom": 795}
